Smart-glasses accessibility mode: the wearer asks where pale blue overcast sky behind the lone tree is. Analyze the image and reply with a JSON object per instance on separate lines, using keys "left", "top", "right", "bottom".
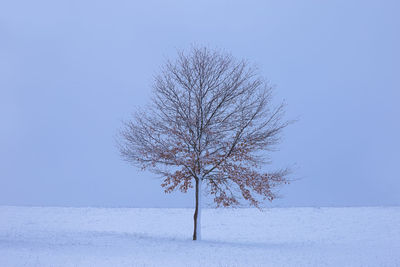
{"left": 0, "top": 0, "right": 400, "bottom": 207}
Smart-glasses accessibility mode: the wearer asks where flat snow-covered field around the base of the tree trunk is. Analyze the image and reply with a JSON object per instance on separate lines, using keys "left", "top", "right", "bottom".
{"left": 0, "top": 207, "right": 400, "bottom": 267}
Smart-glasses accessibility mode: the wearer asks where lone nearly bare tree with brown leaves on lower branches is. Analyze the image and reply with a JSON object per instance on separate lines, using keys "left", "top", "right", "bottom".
{"left": 119, "top": 47, "right": 288, "bottom": 240}
